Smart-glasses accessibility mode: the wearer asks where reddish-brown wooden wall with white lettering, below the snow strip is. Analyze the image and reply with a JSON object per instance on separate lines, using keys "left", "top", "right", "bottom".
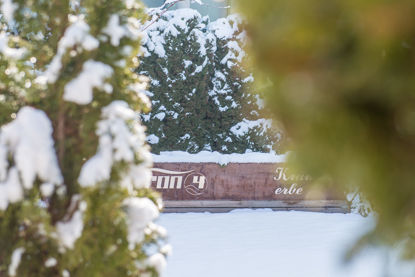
{"left": 152, "top": 163, "right": 344, "bottom": 202}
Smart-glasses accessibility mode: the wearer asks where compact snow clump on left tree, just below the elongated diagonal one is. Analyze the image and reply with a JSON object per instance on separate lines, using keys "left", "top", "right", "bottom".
{"left": 63, "top": 60, "right": 113, "bottom": 104}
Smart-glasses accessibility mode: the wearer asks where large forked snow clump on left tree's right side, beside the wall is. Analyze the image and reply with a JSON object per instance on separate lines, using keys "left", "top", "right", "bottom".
{"left": 78, "top": 101, "right": 152, "bottom": 188}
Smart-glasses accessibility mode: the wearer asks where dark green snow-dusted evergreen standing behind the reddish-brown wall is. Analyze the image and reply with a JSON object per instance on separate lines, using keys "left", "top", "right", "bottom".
{"left": 137, "top": 9, "right": 281, "bottom": 153}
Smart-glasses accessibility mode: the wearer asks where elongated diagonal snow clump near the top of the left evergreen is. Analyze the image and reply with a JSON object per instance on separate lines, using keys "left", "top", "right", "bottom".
{"left": 36, "top": 16, "right": 99, "bottom": 84}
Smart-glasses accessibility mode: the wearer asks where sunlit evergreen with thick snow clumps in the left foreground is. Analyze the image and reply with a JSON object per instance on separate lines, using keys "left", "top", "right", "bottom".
{"left": 0, "top": 0, "right": 168, "bottom": 277}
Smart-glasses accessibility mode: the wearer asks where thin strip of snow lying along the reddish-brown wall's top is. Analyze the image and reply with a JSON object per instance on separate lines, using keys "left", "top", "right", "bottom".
{"left": 153, "top": 151, "right": 286, "bottom": 165}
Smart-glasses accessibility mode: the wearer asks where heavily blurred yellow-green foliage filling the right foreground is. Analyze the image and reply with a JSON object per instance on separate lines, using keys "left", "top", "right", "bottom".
{"left": 238, "top": 0, "right": 415, "bottom": 259}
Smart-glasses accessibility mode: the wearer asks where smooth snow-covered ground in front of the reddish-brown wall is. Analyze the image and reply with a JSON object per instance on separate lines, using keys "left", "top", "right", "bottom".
{"left": 159, "top": 210, "right": 415, "bottom": 277}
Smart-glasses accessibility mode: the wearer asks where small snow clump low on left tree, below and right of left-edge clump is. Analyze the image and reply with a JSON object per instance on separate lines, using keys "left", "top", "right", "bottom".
{"left": 56, "top": 195, "right": 87, "bottom": 249}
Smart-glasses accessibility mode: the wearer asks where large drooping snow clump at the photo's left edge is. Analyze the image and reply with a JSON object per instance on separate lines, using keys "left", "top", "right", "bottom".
{"left": 0, "top": 107, "right": 63, "bottom": 210}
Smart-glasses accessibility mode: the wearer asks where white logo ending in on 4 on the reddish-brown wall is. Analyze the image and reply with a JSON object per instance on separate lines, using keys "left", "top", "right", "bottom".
{"left": 151, "top": 168, "right": 207, "bottom": 196}
